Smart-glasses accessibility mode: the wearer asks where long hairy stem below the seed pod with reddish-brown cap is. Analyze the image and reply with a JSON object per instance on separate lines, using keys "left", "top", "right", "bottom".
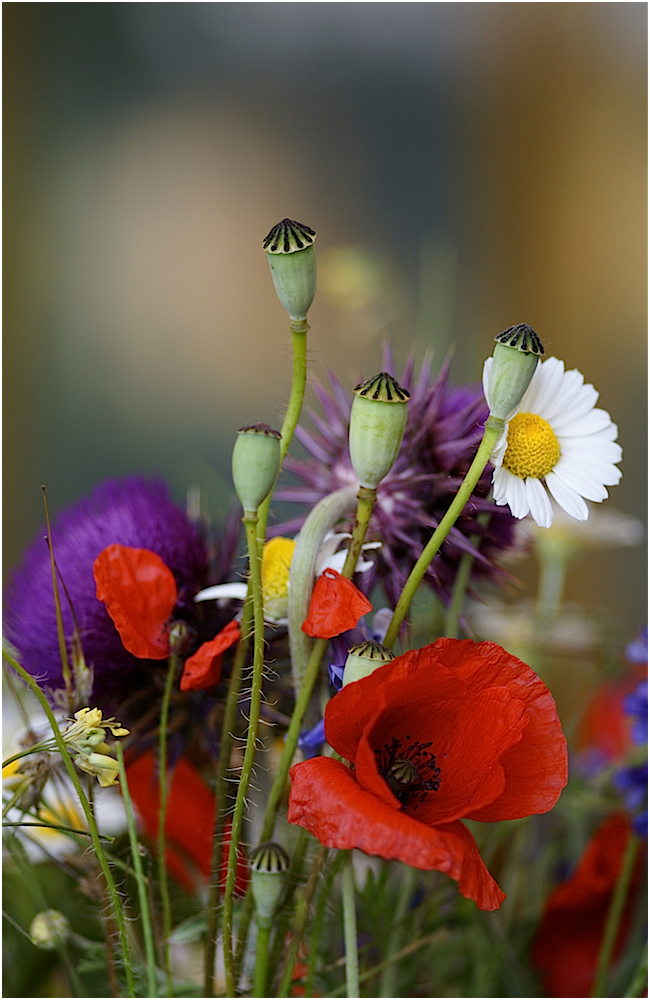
{"left": 222, "top": 511, "right": 267, "bottom": 997}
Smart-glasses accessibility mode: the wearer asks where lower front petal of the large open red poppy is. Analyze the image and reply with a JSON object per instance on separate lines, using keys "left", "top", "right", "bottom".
{"left": 287, "top": 757, "right": 505, "bottom": 910}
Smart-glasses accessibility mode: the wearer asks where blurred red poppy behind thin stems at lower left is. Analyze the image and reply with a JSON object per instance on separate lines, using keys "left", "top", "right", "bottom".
{"left": 126, "top": 750, "right": 248, "bottom": 895}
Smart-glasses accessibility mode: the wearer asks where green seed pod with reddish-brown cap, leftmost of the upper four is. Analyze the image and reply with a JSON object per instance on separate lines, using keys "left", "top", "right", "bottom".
{"left": 232, "top": 424, "right": 281, "bottom": 513}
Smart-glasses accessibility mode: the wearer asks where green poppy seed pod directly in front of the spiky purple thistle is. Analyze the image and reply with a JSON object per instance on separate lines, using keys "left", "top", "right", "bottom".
{"left": 350, "top": 372, "right": 410, "bottom": 490}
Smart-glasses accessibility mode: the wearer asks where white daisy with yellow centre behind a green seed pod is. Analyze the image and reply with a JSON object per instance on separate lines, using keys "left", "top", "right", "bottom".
{"left": 483, "top": 358, "right": 623, "bottom": 528}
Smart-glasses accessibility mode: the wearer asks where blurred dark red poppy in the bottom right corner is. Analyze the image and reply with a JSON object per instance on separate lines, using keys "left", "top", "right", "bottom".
{"left": 531, "top": 815, "right": 641, "bottom": 997}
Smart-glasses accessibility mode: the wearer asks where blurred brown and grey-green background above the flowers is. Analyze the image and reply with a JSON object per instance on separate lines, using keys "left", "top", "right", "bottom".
{"left": 2, "top": 3, "right": 647, "bottom": 637}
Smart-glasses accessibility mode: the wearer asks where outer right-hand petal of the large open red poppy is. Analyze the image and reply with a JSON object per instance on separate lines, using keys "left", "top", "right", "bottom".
{"left": 426, "top": 639, "right": 568, "bottom": 823}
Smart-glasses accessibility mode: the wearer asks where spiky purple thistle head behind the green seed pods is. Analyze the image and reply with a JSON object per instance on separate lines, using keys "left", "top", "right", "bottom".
{"left": 274, "top": 348, "right": 516, "bottom": 606}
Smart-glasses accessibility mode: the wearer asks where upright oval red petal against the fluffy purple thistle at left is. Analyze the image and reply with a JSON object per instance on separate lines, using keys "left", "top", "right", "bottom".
{"left": 93, "top": 545, "right": 178, "bottom": 660}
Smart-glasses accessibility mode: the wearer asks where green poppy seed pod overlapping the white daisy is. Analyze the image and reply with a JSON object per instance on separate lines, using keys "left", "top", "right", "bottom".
{"left": 488, "top": 323, "right": 544, "bottom": 420}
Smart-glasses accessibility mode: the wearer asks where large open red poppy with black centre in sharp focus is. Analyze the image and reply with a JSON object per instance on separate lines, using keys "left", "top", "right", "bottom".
{"left": 288, "top": 639, "right": 567, "bottom": 910}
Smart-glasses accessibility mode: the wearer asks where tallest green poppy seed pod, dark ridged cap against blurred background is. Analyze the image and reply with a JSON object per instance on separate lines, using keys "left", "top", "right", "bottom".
{"left": 262, "top": 219, "right": 316, "bottom": 320}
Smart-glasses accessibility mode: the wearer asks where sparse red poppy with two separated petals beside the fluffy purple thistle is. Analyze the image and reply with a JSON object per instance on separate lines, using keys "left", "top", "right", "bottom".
{"left": 93, "top": 545, "right": 239, "bottom": 691}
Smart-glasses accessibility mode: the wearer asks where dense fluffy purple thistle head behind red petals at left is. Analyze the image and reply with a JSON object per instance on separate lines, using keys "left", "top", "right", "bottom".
{"left": 5, "top": 477, "right": 208, "bottom": 701}
